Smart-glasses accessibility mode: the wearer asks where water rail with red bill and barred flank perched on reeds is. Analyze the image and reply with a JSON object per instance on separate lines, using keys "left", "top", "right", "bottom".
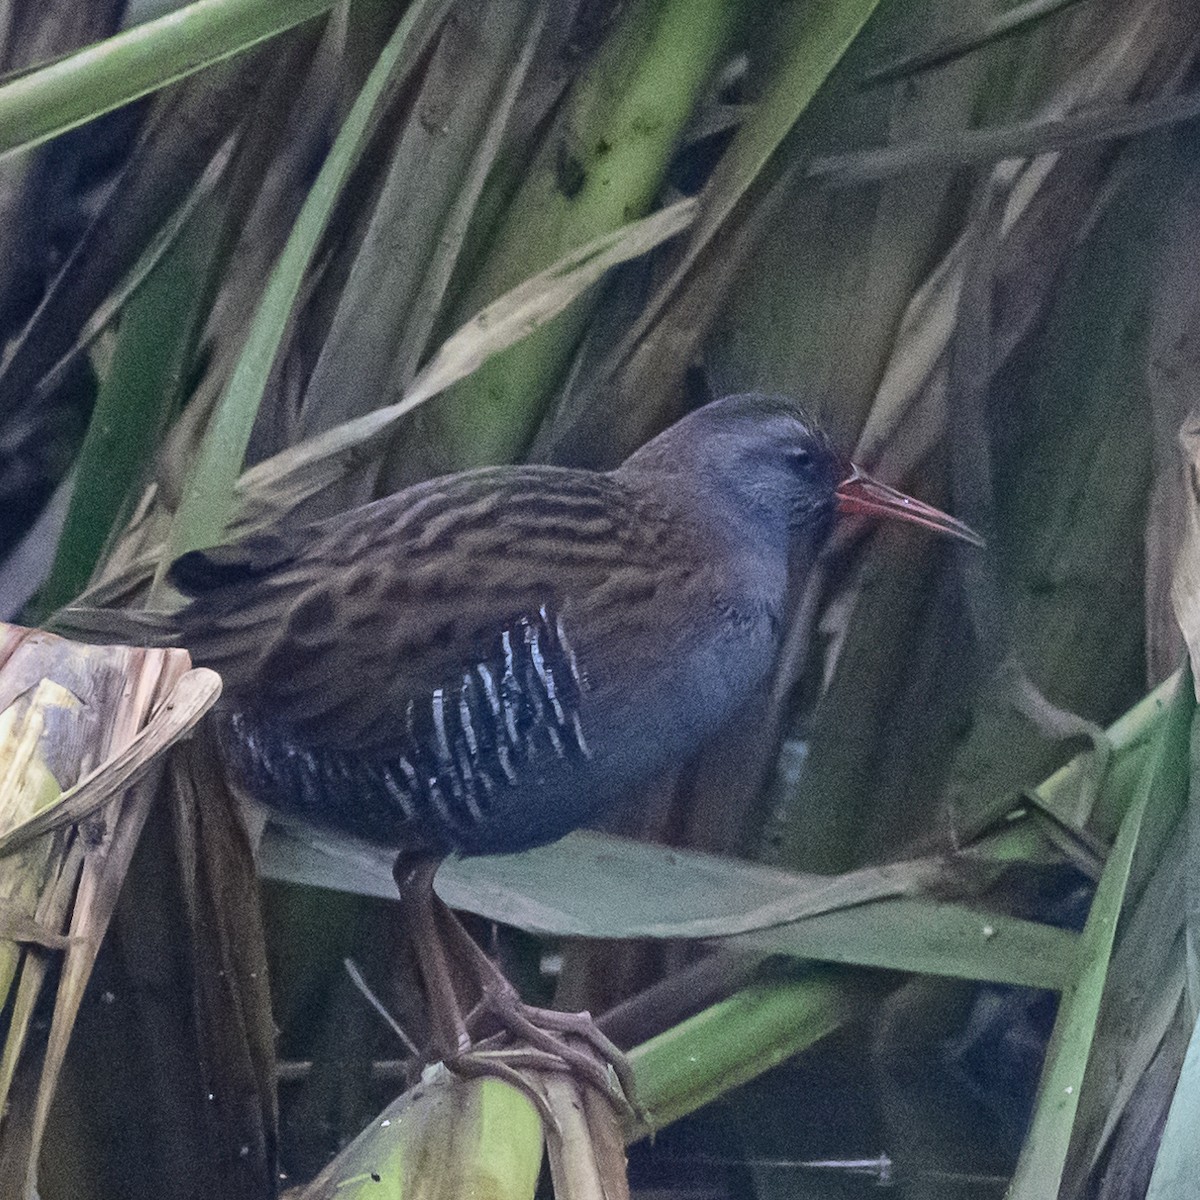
{"left": 56, "top": 394, "right": 979, "bottom": 1099}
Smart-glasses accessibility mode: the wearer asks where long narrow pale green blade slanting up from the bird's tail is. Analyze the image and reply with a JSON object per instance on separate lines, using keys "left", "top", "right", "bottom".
{"left": 158, "top": 0, "right": 446, "bottom": 581}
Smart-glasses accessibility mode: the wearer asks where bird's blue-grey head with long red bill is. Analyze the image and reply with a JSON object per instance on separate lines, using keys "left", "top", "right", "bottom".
{"left": 628, "top": 392, "right": 983, "bottom": 546}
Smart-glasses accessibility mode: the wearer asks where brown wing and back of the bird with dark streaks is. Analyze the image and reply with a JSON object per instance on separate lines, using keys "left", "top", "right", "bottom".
{"left": 175, "top": 467, "right": 691, "bottom": 746}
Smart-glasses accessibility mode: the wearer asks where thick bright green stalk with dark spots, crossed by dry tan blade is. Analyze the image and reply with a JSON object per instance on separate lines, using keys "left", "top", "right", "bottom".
{"left": 438, "top": 0, "right": 736, "bottom": 467}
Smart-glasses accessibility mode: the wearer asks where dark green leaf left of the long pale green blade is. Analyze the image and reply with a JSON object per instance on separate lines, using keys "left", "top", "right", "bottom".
{"left": 32, "top": 198, "right": 221, "bottom": 620}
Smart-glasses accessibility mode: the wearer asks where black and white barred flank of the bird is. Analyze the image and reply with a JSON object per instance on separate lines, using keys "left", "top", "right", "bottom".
{"left": 221, "top": 606, "right": 592, "bottom": 854}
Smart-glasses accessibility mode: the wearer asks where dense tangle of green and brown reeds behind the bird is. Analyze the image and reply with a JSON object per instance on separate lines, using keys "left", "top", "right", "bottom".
{"left": 0, "top": 0, "right": 1200, "bottom": 1200}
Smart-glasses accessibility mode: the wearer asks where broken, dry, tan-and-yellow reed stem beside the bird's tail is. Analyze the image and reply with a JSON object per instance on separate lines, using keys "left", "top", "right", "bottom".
{"left": 0, "top": 623, "right": 221, "bottom": 1196}
